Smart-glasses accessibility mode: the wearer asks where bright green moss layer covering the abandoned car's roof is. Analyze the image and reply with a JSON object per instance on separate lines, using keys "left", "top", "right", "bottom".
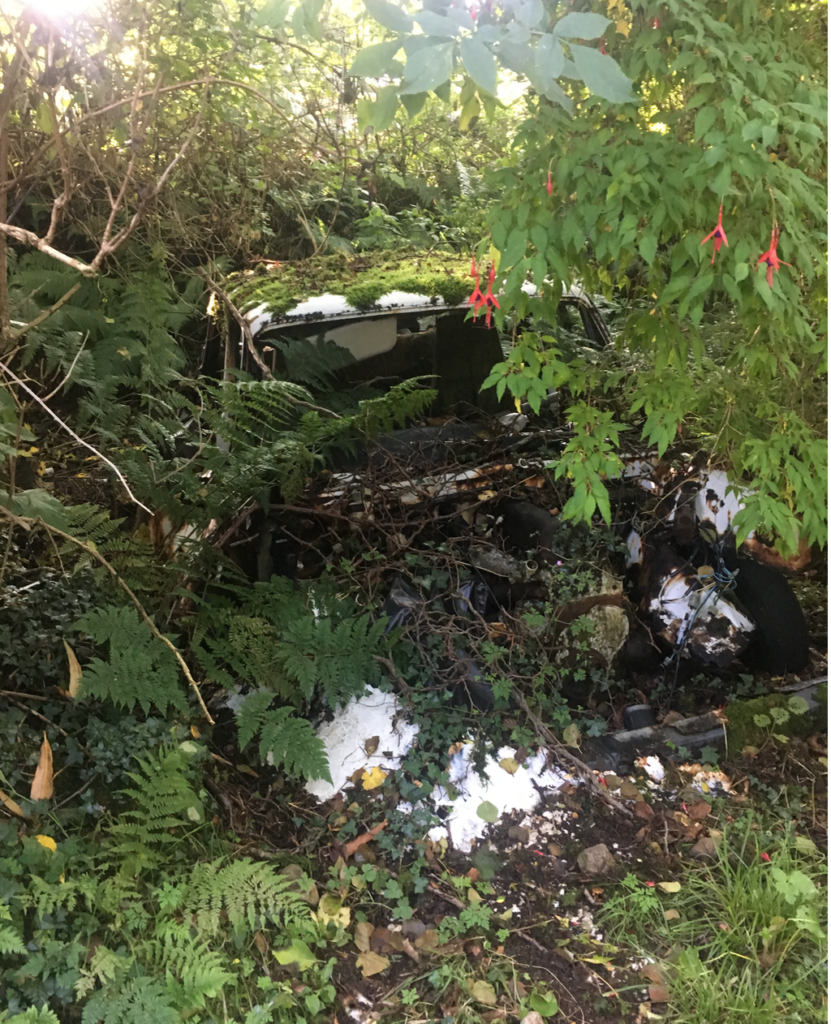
{"left": 227, "top": 252, "right": 473, "bottom": 318}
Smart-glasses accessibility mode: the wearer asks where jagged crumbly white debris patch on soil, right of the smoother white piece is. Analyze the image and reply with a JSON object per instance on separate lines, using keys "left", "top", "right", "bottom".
{"left": 430, "top": 743, "right": 566, "bottom": 853}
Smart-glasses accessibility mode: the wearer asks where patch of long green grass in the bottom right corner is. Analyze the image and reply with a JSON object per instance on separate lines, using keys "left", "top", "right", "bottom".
{"left": 601, "top": 812, "right": 828, "bottom": 1024}
